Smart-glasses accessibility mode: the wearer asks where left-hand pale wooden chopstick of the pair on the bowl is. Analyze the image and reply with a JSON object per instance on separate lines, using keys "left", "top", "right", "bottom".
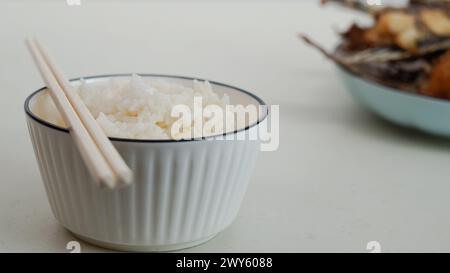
{"left": 26, "top": 39, "right": 132, "bottom": 188}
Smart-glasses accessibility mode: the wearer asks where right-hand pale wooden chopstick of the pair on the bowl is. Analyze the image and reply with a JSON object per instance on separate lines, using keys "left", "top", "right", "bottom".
{"left": 33, "top": 38, "right": 133, "bottom": 184}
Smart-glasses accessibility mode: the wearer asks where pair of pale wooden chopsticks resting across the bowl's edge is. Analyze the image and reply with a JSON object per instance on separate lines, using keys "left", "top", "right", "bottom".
{"left": 26, "top": 38, "right": 133, "bottom": 188}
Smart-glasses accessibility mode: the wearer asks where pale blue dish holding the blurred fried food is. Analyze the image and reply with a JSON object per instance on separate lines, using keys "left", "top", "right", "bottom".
{"left": 338, "top": 67, "right": 450, "bottom": 137}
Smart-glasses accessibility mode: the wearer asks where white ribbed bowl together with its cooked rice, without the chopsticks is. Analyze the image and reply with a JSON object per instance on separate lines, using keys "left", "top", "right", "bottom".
{"left": 25, "top": 74, "right": 268, "bottom": 251}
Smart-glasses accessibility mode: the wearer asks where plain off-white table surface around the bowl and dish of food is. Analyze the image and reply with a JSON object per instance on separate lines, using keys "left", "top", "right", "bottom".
{"left": 0, "top": 0, "right": 450, "bottom": 252}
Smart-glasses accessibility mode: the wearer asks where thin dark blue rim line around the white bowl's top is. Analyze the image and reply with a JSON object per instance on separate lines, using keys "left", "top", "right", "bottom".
{"left": 24, "top": 73, "right": 269, "bottom": 143}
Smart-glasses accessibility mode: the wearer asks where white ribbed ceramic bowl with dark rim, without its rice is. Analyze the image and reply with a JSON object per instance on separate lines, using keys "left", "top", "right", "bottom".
{"left": 25, "top": 75, "right": 268, "bottom": 251}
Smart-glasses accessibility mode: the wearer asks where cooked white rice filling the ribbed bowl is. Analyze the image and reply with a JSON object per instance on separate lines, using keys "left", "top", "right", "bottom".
{"left": 32, "top": 75, "right": 245, "bottom": 139}
